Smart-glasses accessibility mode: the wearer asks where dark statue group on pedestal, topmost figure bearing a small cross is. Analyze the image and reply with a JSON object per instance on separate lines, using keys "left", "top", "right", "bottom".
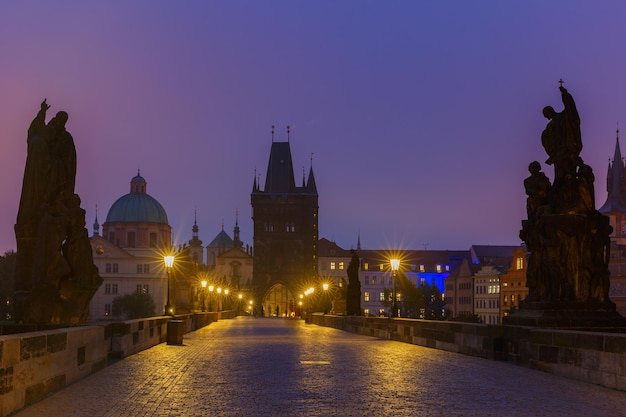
{"left": 505, "top": 80, "right": 624, "bottom": 327}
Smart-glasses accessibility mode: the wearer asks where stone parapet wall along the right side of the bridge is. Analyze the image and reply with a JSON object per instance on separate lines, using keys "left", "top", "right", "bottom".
{"left": 309, "top": 314, "right": 626, "bottom": 391}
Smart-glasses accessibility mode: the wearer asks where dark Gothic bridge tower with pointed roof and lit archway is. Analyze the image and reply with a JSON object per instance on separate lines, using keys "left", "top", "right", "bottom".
{"left": 251, "top": 136, "right": 319, "bottom": 315}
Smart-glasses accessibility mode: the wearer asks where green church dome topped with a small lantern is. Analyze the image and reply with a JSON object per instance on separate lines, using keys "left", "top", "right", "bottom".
{"left": 106, "top": 173, "right": 168, "bottom": 224}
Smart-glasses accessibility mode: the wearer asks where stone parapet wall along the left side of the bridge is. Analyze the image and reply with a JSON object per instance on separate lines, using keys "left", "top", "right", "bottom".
{"left": 0, "top": 311, "right": 236, "bottom": 417}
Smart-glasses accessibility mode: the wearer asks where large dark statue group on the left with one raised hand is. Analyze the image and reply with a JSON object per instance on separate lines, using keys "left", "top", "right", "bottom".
{"left": 14, "top": 100, "right": 102, "bottom": 324}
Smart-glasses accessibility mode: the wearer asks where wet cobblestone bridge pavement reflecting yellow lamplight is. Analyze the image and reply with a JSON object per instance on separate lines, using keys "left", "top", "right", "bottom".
{"left": 9, "top": 317, "right": 626, "bottom": 417}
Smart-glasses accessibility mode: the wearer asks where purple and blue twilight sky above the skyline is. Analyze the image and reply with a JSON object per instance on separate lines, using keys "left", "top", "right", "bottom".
{"left": 0, "top": 0, "right": 626, "bottom": 253}
